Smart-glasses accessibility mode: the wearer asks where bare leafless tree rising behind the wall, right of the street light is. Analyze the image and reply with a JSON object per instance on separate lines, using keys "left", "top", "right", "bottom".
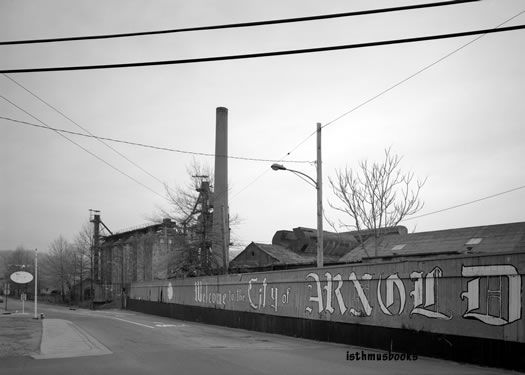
{"left": 329, "top": 149, "right": 426, "bottom": 255}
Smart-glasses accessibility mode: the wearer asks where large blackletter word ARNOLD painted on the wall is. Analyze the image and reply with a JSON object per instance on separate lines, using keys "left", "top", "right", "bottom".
{"left": 302, "top": 265, "right": 521, "bottom": 326}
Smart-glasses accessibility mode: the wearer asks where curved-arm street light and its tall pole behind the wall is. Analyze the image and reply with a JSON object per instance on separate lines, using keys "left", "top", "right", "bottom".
{"left": 271, "top": 123, "right": 324, "bottom": 268}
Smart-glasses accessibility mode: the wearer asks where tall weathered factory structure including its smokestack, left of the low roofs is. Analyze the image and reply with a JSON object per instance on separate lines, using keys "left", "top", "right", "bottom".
{"left": 90, "top": 107, "right": 230, "bottom": 304}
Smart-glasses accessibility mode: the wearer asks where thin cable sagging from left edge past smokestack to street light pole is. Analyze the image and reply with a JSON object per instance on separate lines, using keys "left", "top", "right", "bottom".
{"left": 0, "top": 116, "right": 311, "bottom": 163}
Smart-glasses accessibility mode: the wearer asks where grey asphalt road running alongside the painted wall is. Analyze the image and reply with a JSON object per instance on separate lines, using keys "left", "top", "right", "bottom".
{"left": 0, "top": 299, "right": 513, "bottom": 375}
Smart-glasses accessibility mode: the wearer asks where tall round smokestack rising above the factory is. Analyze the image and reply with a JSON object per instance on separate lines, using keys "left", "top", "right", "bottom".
{"left": 212, "top": 107, "right": 230, "bottom": 272}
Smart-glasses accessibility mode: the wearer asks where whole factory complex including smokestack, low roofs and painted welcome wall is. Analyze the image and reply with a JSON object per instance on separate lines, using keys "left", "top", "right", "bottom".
{"left": 88, "top": 108, "right": 525, "bottom": 371}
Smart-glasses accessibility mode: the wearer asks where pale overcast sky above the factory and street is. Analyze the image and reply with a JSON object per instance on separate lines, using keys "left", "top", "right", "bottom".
{"left": 0, "top": 0, "right": 525, "bottom": 251}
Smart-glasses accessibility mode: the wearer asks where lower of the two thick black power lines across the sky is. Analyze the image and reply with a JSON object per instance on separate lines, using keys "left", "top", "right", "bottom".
{"left": 0, "top": 25, "right": 525, "bottom": 74}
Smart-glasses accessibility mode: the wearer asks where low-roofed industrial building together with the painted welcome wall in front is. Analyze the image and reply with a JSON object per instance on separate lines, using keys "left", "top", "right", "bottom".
{"left": 127, "top": 222, "right": 525, "bottom": 370}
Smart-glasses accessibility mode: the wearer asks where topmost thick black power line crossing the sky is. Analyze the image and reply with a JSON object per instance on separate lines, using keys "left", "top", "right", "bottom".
{"left": 0, "top": 0, "right": 480, "bottom": 45}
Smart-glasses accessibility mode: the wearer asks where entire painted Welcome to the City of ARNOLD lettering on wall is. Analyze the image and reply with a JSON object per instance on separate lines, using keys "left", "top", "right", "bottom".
{"left": 190, "top": 262, "right": 522, "bottom": 326}
